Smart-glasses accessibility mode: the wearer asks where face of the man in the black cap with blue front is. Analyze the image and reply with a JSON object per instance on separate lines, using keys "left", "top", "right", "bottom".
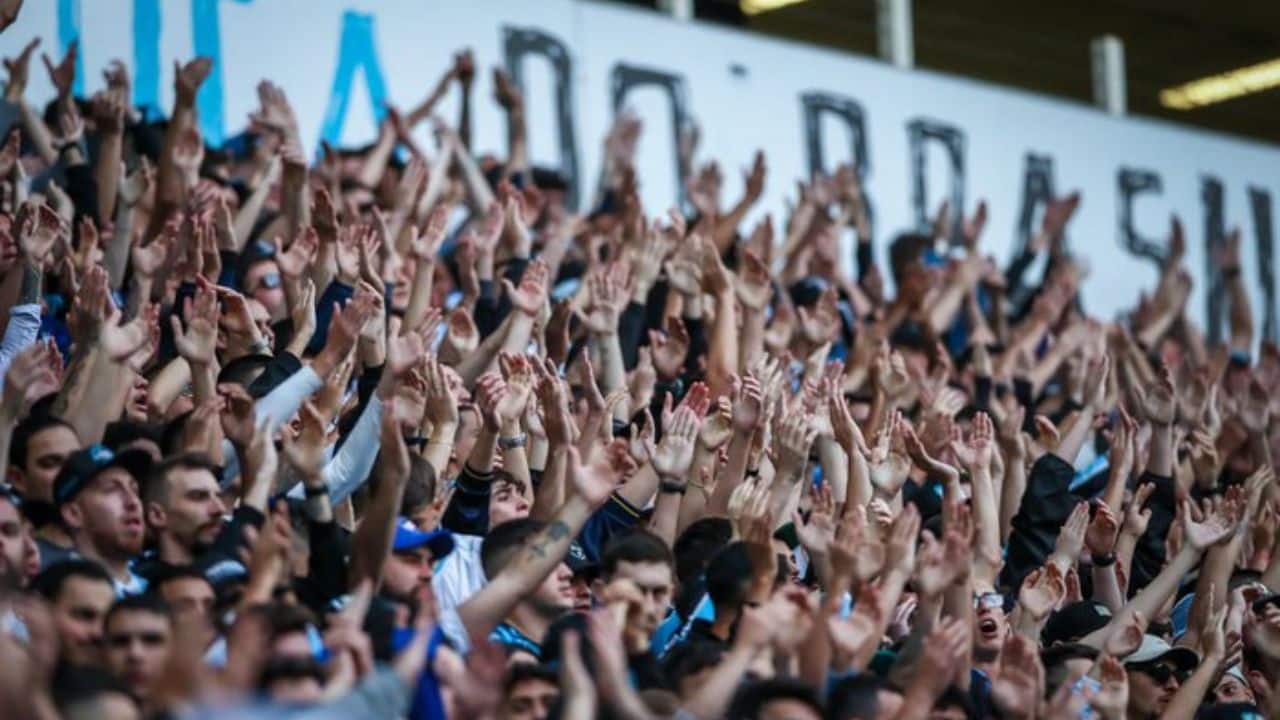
{"left": 63, "top": 468, "right": 146, "bottom": 557}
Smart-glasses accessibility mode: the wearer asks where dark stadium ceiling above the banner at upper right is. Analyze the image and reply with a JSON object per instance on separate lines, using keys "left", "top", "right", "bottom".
{"left": 606, "top": 0, "right": 1280, "bottom": 142}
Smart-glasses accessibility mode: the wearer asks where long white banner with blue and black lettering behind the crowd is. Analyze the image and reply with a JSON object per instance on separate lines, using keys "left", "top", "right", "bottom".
{"left": 0, "top": 0, "right": 1280, "bottom": 337}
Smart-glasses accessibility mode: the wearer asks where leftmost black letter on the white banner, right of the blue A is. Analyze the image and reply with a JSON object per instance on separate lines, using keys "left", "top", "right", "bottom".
{"left": 502, "top": 26, "right": 581, "bottom": 210}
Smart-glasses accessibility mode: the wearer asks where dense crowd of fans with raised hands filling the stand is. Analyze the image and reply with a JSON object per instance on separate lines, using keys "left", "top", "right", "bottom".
{"left": 0, "top": 11, "right": 1280, "bottom": 720}
